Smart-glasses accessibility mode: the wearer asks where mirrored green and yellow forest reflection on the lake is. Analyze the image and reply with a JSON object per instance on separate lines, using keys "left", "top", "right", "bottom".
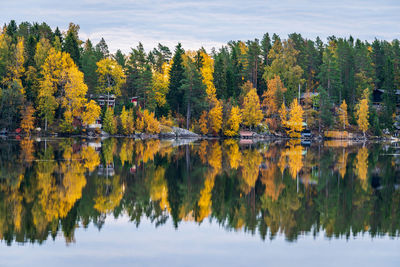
{"left": 0, "top": 139, "right": 400, "bottom": 244}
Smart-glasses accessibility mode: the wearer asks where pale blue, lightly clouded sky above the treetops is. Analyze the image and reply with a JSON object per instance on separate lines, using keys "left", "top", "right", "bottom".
{"left": 0, "top": 0, "right": 400, "bottom": 53}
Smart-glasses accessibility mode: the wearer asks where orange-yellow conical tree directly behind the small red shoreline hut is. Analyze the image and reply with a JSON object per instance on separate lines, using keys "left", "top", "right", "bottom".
{"left": 242, "top": 88, "right": 263, "bottom": 127}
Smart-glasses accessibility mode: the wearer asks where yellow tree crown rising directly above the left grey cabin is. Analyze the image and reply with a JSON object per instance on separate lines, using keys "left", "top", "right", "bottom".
{"left": 96, "top": 58, "right": 126, "bottom": 96}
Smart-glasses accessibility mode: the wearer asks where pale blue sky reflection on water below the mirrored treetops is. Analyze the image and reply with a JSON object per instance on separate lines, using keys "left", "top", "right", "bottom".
{"left": 0, "top": 217, "right": 400, "bottom": 267}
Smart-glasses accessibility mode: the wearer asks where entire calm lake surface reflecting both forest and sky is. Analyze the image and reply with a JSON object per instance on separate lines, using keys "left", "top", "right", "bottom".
{"left": 0, "top": 139, "right": 400, "bottom": 266}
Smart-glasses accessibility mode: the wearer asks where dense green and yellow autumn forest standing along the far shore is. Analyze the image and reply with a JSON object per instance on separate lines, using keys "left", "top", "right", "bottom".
{"left": 0, "top": 21, "right": 400, "bottom": 136}
